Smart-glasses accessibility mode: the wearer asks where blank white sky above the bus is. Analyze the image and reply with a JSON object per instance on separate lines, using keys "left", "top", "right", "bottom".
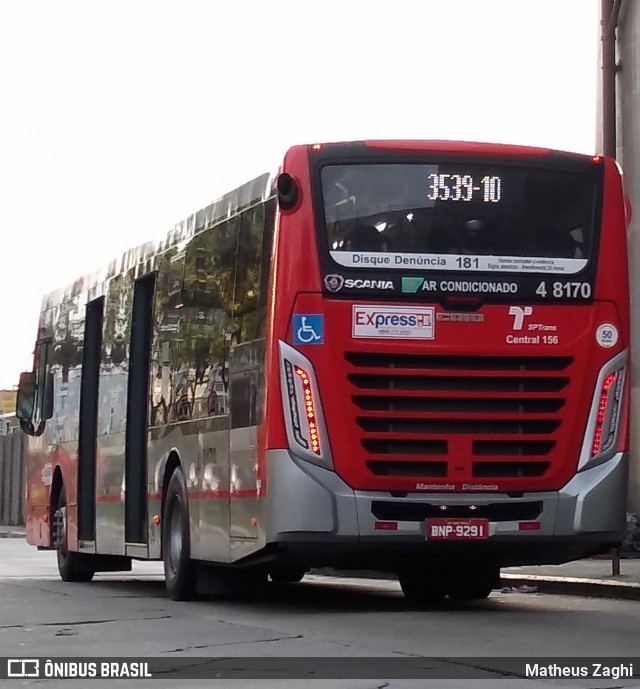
{"left": 0, "top": 0, "right": 599, "bottom": 389}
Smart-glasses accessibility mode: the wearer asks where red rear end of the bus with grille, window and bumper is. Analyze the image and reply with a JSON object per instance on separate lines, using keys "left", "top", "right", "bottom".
{"left": 262, "top": 141, "right": 629, "bottom": 588}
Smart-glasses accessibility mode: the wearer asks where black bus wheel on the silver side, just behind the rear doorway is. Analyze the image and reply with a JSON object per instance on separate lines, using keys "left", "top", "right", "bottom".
{"left": 162, "top": 468, "right": 196, "bottom": 600}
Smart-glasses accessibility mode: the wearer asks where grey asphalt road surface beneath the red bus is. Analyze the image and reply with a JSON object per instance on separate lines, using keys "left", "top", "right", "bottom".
{"left": 0, "top": 539, "right": 640, "bottom": 689}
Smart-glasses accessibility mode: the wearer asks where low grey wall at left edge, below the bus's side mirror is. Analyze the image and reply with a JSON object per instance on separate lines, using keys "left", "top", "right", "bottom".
{"left": 0, "top": 431, "right": 26, "bottom": 526}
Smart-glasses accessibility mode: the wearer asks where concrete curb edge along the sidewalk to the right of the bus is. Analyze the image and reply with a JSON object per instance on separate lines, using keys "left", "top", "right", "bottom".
{"left": 500, "top": 574, "right": 640, "bottom": 600}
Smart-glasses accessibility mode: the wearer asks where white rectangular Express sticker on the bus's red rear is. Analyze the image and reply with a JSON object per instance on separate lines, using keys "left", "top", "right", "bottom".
{"left": 352, "top": 305, "right": 435, "bottom": 340}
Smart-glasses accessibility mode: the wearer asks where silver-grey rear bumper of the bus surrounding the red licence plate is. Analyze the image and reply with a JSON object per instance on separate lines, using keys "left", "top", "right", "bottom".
{"left": 265, "top": 451, "right": 628, "bottom": 569}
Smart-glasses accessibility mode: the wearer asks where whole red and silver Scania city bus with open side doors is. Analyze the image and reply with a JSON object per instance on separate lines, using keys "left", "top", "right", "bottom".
{"left": 17, "top": 141, "right": 629, "bottom": 603}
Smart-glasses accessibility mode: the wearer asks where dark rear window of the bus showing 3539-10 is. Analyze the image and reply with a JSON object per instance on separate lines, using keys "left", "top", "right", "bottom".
{"left": 321, "top": 162, "right": 597, "bottom": 274}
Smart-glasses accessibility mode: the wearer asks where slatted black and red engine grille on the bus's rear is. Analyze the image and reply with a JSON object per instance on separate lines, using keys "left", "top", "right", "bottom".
{"left": 345, "top": 352, "right": 573, "bottom": 480}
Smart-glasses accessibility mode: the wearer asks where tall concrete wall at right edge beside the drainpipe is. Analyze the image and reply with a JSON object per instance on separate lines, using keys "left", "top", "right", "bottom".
{"left": 612, "top": 0, "right": 640, "bottom": 513}
